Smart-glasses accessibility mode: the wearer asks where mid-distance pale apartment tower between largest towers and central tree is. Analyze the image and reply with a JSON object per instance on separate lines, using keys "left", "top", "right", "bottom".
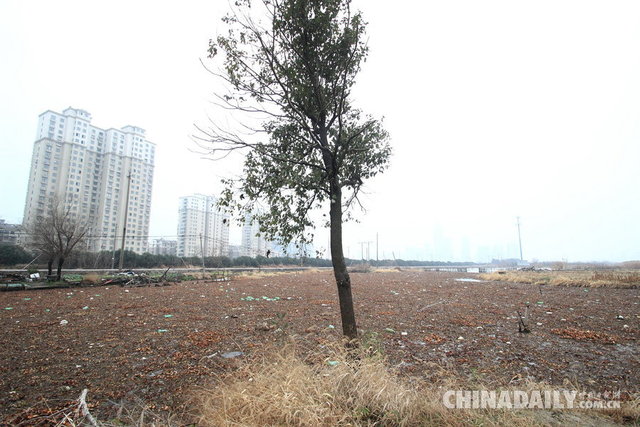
{"left": 178, "top": 194, "right": 229, "bottom": 257}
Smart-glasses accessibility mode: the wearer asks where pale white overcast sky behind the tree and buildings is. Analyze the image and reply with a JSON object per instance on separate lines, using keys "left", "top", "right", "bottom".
{"left": 0, "top": 0, "right": 640, "bottom": 261}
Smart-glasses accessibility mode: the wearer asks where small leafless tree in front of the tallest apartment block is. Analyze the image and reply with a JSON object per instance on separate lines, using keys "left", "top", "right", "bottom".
{"left": 30, "top": 198, "right": 89, "bottom": 280}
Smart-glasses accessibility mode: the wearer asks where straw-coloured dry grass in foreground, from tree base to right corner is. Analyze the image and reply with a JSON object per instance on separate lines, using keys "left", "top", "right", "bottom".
{"left": 191, "top": 343, "right": 638, "bottom": 426}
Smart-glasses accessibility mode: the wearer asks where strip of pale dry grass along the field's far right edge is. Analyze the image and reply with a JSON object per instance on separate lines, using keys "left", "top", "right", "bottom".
{"left": 480, "top": 270, "right": 640, "bottom": 288}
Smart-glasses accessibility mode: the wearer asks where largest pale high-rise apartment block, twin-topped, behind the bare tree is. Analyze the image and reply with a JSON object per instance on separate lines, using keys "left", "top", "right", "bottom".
{"left": 23, "top": 107, "right": 155, "bottom": 253}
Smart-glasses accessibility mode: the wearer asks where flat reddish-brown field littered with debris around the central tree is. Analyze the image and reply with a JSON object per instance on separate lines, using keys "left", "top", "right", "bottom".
{"left": 0, "top": 270, "right": 640, "bottom": 423}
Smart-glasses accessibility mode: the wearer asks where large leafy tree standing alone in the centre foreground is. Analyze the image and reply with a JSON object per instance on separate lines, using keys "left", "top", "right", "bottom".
{"left": 201, "top": 0, "right": 391, "bottom": 338}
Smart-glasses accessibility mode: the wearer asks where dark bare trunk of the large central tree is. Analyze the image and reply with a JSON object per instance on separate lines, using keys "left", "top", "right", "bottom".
{"left": 330, "top": 184, "right": 358, "bottom": 338}
